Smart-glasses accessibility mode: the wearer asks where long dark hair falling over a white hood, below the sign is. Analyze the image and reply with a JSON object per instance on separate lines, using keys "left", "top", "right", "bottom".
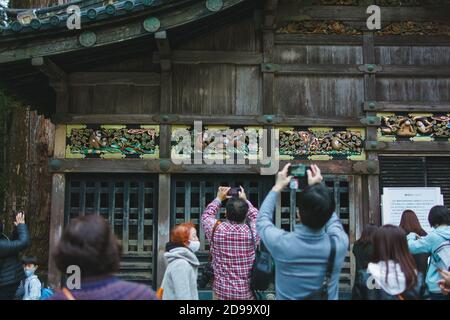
{"left": 372, "top": 224, "right": 417, "bottom": 290}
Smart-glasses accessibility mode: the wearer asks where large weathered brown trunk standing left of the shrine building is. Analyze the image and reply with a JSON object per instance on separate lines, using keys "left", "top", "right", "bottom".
{"left": 2, "top": 107, "right": 54, "bottom": 281}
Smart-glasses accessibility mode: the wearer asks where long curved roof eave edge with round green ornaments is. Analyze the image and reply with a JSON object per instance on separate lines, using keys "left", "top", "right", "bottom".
{"left": 0, "top": 0, "right": 252, "bottom": 64}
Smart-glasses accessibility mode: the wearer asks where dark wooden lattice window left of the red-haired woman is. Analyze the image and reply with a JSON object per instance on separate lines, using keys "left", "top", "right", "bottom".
{"left": 65, "top": 174, "right": 157, "bottom": 284}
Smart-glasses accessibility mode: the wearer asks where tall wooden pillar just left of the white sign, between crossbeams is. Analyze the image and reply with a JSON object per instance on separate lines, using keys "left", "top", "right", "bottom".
{"left": 363, "top": 32, "right": 381, "bottom": 225}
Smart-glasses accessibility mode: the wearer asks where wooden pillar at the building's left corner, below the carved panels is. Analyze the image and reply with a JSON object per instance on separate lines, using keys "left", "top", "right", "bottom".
{"left": 48, "top": 174, "right": 66, "bottom": 288}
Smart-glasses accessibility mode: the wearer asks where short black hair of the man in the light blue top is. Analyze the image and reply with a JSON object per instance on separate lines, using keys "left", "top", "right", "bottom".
{"left": 297, "top": 183, "right": 335, "bottom": 229}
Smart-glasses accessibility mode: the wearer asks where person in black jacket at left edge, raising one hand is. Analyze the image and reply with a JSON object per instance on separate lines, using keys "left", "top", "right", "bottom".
{"left": 0, "top": 212, "right": 29, "bottom": 300}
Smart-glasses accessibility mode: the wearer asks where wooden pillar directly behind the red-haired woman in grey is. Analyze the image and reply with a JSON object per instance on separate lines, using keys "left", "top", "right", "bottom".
{"left": 156, "top": 173, "right": 170, "bottom": 288}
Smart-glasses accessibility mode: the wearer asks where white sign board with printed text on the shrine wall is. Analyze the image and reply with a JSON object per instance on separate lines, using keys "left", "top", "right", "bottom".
{"left": 381, "top": 187, "right": 444, "bottom": 232}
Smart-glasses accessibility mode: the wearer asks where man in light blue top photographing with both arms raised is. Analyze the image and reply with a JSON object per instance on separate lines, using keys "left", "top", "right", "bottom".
{"left": 256, "top": 164, "right": 349, "bottom": 300}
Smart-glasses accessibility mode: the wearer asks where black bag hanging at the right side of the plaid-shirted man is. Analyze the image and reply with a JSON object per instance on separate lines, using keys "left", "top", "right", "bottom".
{"left": 246, "top": 220, "right": 275, "bottom": 296}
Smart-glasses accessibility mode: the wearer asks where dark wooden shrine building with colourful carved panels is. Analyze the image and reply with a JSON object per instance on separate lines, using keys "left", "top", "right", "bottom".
{"left": 0, "top": 0, "right": 450, "bottom": 298}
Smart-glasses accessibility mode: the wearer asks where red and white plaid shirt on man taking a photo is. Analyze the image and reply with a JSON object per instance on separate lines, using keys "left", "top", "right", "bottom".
{"left": 202, "top": 199, "right": 259, "bottom": 300}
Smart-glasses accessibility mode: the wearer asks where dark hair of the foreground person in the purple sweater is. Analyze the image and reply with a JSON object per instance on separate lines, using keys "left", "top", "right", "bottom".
{"left": 54, "top": 215, "right": 121, "bottom": 278}
